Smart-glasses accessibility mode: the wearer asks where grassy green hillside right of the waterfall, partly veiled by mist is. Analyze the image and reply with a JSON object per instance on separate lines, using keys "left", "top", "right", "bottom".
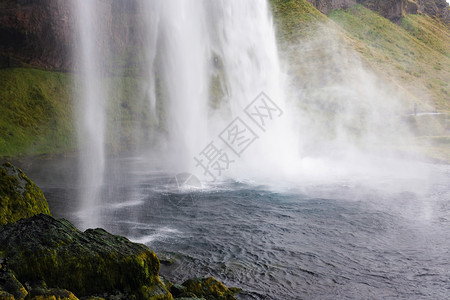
{"left": 271, "top": 0, "right": 450, "bottom": 162}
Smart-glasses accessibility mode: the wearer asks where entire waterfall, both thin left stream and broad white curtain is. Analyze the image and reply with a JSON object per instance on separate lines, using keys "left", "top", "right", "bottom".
{"left": 73, "top": 0, "right": 295, "bottom": 227}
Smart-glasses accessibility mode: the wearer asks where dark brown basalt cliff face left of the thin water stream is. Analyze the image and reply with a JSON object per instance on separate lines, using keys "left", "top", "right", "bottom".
{"left": 0, "top": 0, "right": 72, "bottom": 69}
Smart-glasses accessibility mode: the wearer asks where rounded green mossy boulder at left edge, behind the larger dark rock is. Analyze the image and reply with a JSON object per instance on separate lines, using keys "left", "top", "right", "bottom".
{"left": 0, "top": 162, "right": 50, "bottom": 225}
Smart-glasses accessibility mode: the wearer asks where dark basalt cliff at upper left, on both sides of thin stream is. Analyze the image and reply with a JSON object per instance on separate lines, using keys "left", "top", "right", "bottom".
{"left": 0, "top": 0, "right": 142, "bottom": 71}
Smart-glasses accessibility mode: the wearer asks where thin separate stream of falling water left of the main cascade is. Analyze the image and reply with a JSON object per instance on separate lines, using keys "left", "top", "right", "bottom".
{"left": 73, "top": 1, "right": 106, "bottom": 228}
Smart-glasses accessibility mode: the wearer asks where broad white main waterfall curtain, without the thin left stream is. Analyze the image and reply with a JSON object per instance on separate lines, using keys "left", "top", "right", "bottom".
{"left": 142, "top": 0, "right": 295, "bottom": 179}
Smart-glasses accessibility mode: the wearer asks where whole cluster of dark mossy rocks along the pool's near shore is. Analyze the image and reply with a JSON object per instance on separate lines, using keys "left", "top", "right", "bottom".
{"left": 0, "top": 163, "right": 241, "bottom": 300}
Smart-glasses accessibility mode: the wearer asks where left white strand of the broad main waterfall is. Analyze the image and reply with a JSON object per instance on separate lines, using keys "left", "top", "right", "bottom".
{"left": 160, "top": 0, "right": 208, "bottom": 170}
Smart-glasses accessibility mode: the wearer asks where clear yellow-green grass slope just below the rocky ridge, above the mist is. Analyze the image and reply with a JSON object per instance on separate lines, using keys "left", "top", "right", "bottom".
{"left": 329, "top": 5, "right": 450, "bottom": 111}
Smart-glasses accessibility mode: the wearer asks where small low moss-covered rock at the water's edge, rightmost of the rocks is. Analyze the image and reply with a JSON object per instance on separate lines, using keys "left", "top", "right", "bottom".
{"left": 180, "top": 277, "right": 236, "bottom": 300}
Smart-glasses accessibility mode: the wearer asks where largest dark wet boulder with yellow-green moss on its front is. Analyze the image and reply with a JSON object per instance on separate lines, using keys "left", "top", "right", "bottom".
{"left": 0, "top": 214, "right": 173, "bottom": 300}
